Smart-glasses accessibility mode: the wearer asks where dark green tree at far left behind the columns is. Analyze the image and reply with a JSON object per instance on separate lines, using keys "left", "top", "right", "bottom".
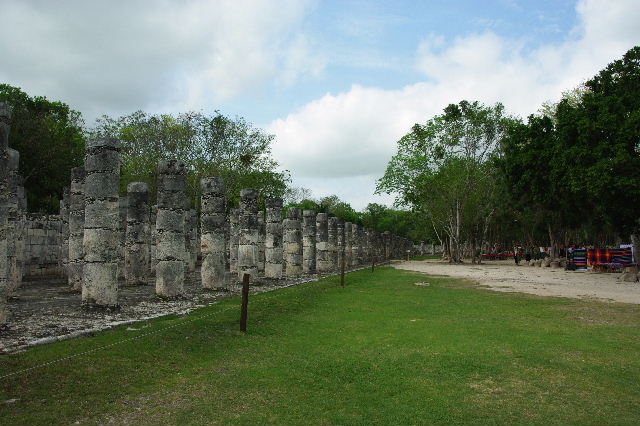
{"left": 0, "top": 84, "right": 85, "bottom": 213}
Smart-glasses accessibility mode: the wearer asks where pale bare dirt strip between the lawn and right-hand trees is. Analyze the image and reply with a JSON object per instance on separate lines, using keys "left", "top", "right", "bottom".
{"left": 394, "top": 260, "right": 640, "bottom": 304}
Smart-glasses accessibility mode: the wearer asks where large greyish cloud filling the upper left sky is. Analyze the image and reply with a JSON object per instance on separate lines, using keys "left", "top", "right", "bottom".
{"left": 0, "top": 0, "right": 324, "bottom": 117}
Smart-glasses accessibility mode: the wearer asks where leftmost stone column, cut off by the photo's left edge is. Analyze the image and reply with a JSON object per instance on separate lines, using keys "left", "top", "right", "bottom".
{"left": 0, "top": 102, "right": 11, "bottom": 326}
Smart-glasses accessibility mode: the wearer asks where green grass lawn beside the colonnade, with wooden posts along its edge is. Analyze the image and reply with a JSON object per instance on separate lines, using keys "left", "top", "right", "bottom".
{"left": 0, "top": 267, "right": 640, "bottom": 425}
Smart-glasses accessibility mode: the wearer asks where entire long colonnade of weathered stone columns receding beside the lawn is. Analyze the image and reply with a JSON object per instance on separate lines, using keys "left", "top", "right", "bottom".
{"left": 0, "top": 103, "right": 413, "bottom": 336}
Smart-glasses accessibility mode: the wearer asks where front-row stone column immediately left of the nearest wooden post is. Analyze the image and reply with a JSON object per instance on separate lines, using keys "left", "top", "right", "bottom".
{"left": 200, "top": 177, "right": 227, "bottom": 289}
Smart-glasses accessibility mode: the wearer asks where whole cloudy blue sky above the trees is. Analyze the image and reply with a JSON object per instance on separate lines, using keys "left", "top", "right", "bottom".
{"left": 0, "top": 0, "right": 640, "bottom": 210}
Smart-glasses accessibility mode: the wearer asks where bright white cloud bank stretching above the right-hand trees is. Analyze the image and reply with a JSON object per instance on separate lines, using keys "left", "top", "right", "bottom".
{"left": 268, "top": 0, "right": 640, "bottom": 209}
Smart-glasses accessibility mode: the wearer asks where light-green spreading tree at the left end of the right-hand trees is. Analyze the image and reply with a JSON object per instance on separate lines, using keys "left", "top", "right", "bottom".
{"left": 376, "top": 101, "right": 513, "bottom": 262}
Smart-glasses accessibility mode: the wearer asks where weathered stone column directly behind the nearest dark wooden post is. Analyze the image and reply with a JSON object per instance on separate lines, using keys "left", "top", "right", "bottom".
{"left": 238, "top": 189, "right": 259, "bottom": 283}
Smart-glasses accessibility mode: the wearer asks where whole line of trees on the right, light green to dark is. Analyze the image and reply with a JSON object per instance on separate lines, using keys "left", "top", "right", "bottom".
{"left": 377, "top": 47, "right": 640, "bottom": 262}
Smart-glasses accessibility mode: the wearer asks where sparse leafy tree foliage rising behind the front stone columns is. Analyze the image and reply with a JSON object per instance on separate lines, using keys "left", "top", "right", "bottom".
{"left": 92, "top": 111, "right": 289, "bottom": 205}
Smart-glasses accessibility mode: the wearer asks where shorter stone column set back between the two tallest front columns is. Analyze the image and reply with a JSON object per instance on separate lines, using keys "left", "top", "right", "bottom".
{"left": 124, "top": 182, "right": 151, "bottom": 285}
